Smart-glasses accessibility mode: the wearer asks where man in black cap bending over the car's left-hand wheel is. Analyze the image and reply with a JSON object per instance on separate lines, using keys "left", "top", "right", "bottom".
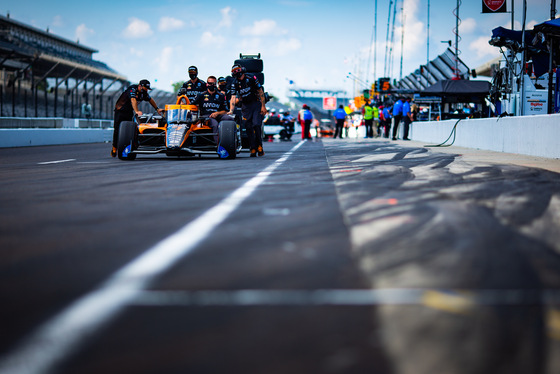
{"left": 111, "top": 79, "right": 163, "bottom": 157}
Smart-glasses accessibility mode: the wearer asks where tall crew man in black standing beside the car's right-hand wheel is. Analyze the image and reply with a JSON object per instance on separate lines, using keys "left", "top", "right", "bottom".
{"left": 228, "top": 64, "right": 266, "bottom": 157}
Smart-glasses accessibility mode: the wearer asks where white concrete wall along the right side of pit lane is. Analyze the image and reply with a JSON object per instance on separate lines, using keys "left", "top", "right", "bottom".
{"left": 406, "top": 114, "right": 560, "bottom": 158}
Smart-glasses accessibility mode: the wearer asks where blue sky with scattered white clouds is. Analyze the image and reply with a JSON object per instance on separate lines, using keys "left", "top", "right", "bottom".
{"left": 0, "top": 0, "right": 550, "bottom": 98}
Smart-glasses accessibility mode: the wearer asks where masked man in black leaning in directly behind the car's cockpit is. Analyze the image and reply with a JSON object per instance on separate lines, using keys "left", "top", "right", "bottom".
{"left": 191, "top": 75, "right": 232, "bottom": 142}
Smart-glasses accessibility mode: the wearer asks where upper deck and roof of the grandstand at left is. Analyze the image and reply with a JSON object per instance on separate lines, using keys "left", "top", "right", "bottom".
{"left": 0, "top": 16, "right": 128, "bottom": 88}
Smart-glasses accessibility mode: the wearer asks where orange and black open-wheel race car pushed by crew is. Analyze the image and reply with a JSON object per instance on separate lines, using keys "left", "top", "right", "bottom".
{"left": 117, "top": 96, "right": 241, "bottom": 160}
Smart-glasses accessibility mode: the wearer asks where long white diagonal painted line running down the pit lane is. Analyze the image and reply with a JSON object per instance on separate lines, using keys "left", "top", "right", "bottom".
{"left": 0, "top": 141, "right": 305, "bottom": 374}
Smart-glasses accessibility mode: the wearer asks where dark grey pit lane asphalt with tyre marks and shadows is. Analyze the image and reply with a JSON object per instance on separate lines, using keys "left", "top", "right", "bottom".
{"left": 0, "top": 139, "right": 560, "bottom": 373}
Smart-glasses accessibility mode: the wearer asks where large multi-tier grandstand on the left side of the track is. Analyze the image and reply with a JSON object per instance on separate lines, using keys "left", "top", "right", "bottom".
{"left": 0, "top": 15, "right": 130, "bottom": 119}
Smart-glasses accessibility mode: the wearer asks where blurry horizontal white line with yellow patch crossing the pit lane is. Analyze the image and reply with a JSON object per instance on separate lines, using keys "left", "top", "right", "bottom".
{"left": 132, "top": 288, "right": 560, "bottom": 306}
